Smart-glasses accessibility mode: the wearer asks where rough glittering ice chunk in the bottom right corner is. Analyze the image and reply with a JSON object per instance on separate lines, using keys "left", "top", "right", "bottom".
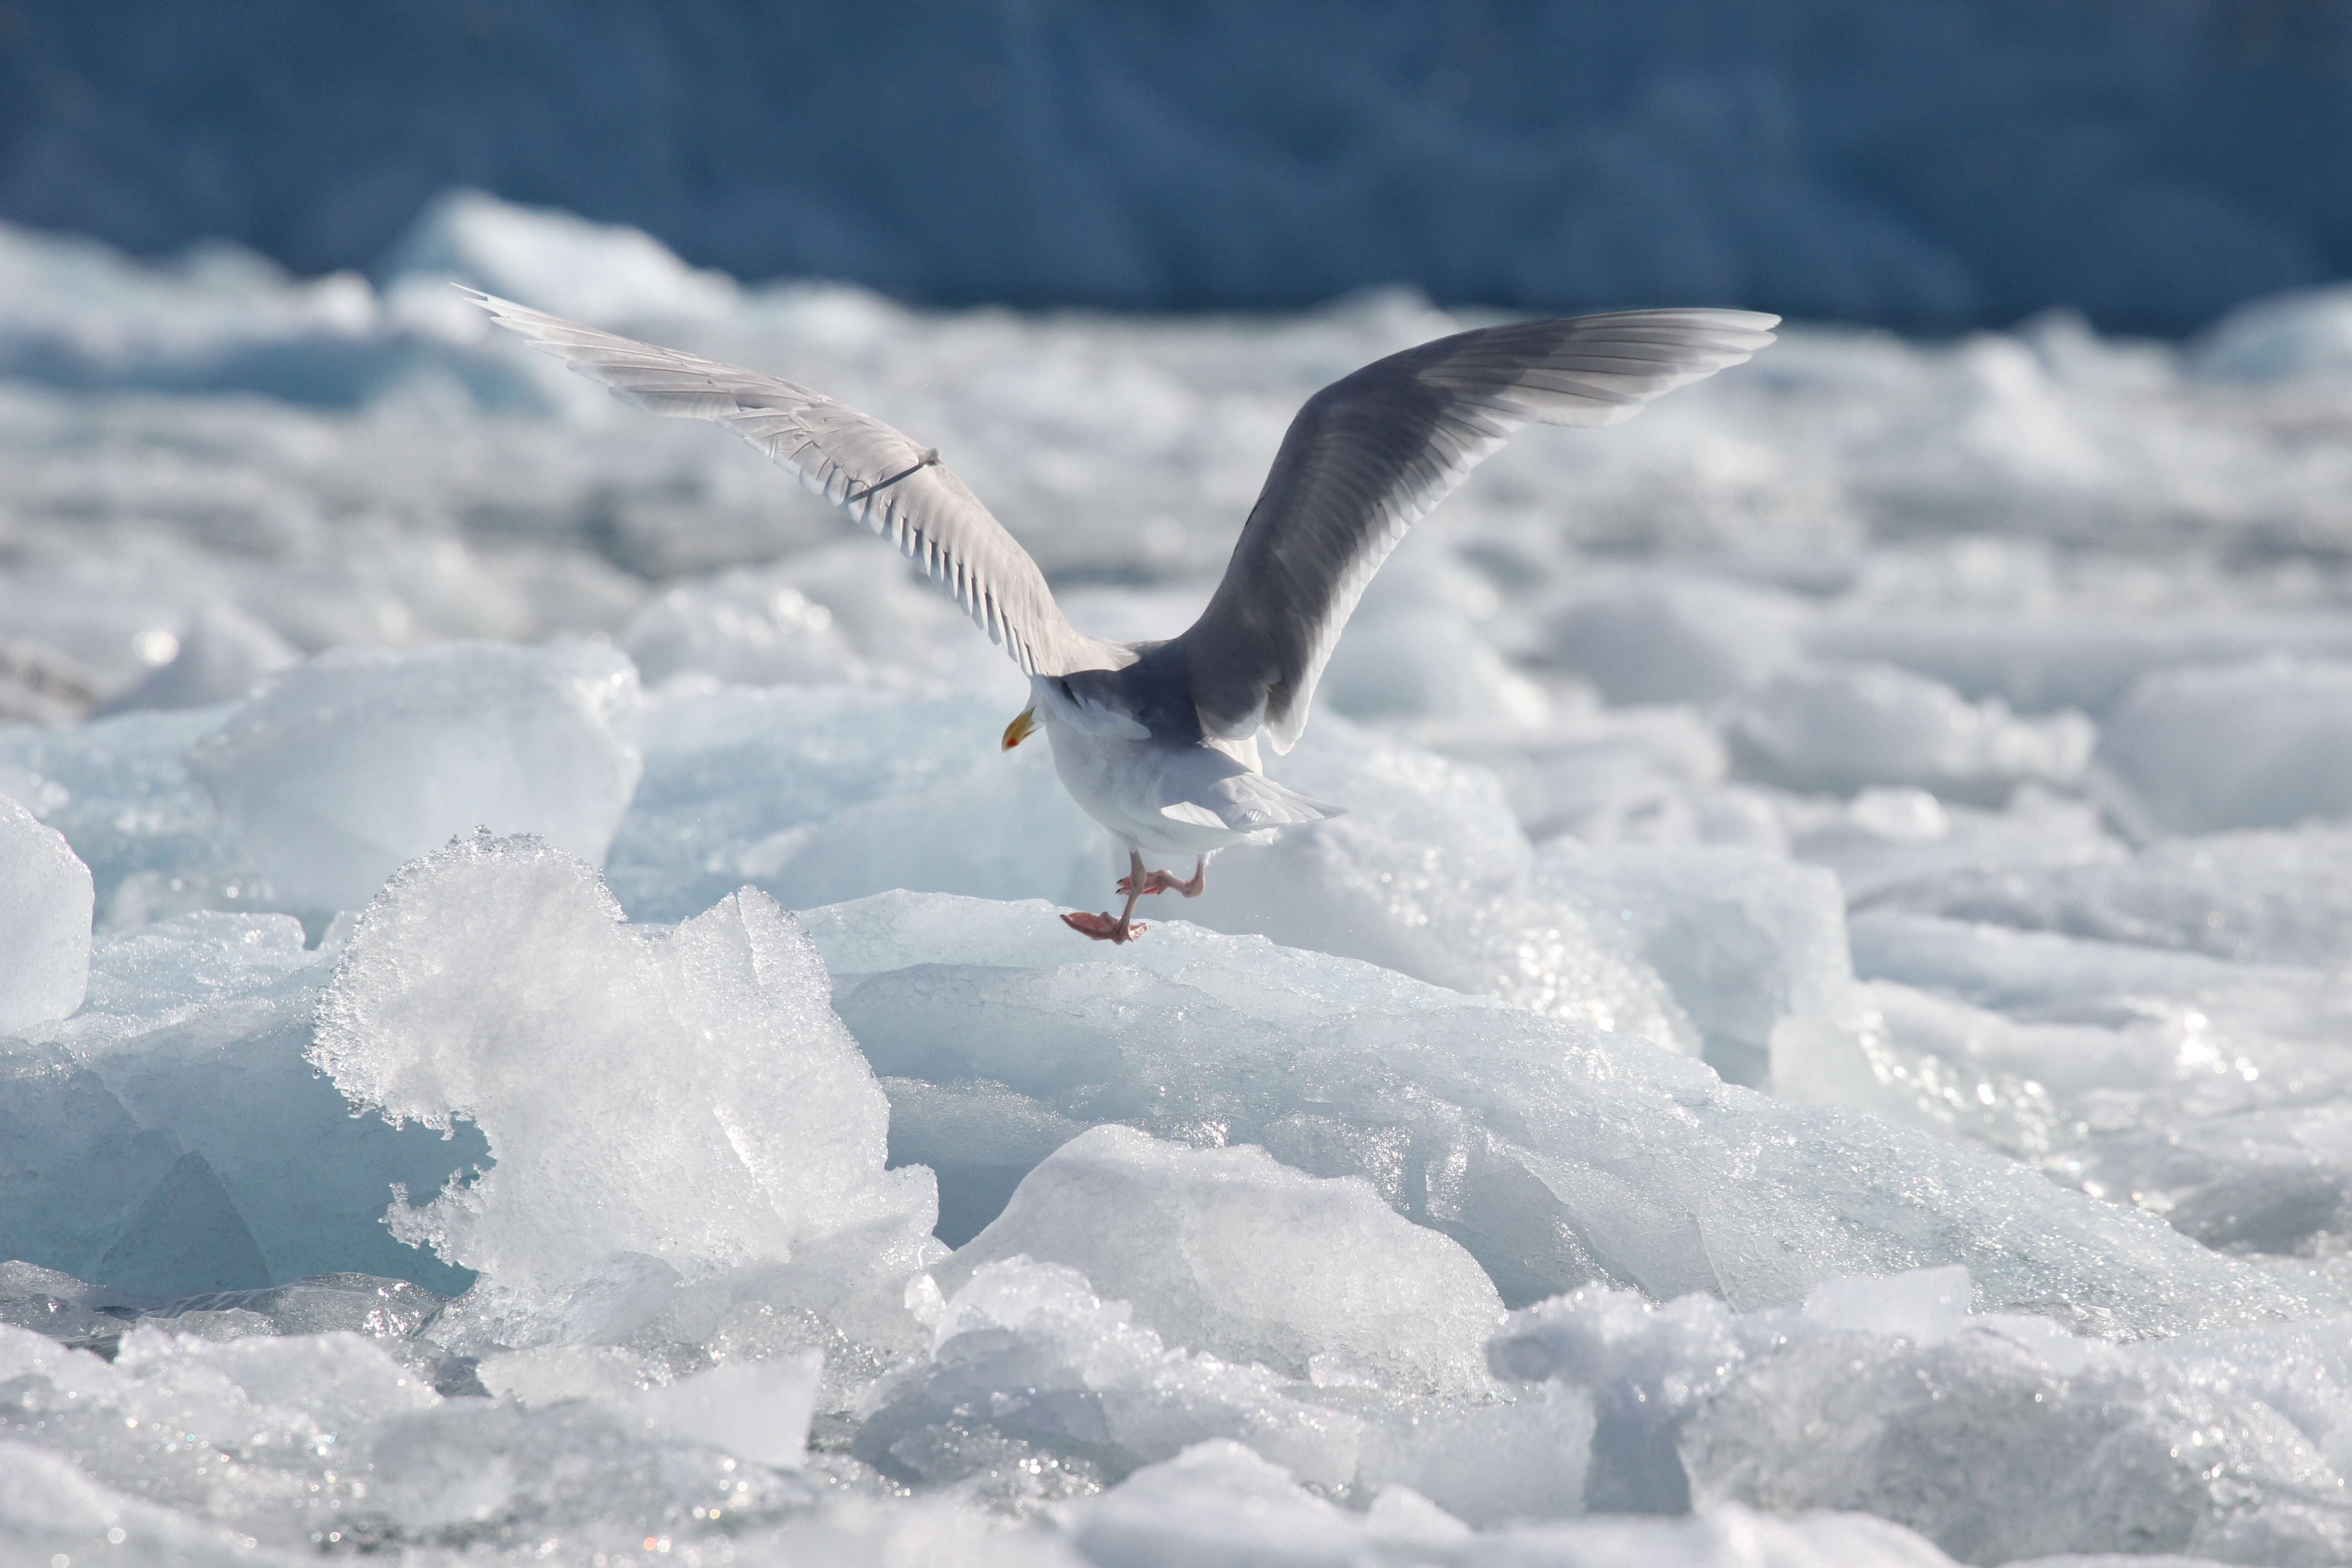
{"left": 1682, "top": 1326, "right": 2352, "bottom": 1563}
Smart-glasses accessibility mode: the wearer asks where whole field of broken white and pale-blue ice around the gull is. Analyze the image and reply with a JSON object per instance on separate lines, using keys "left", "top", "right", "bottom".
{"left": 0, "top": 197, "right": 2352, "bottom": 1568}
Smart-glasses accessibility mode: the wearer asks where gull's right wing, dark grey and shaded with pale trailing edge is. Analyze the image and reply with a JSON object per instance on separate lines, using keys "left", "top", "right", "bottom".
{"left": 1178, "top": 310, "right": 1780, "bottom": 752}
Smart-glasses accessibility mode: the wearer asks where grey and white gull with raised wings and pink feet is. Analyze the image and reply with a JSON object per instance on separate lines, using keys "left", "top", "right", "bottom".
{"left": 461, "top": 284, "right": 1780, "bottom": 943}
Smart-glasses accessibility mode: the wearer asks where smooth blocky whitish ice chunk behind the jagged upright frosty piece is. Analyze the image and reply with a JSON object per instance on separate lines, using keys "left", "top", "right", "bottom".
{"left": 188, "top": 644, "right": 642, "bottom": 910}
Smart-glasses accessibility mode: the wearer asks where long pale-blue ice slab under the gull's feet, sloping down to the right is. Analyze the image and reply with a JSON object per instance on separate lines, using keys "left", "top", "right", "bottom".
{"left": 809, "top": 893, "right": 2338, "bottom": 1333}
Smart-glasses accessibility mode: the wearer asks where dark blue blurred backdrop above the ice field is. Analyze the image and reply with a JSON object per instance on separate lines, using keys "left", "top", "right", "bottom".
{"left": 0, "top": 0, "right": 2352, "bottom": 334}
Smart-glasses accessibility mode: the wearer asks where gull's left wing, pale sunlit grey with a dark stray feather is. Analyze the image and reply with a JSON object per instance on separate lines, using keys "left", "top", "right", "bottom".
{"left": 463, "top": 289, "right": 1129, "bottom": 675}
